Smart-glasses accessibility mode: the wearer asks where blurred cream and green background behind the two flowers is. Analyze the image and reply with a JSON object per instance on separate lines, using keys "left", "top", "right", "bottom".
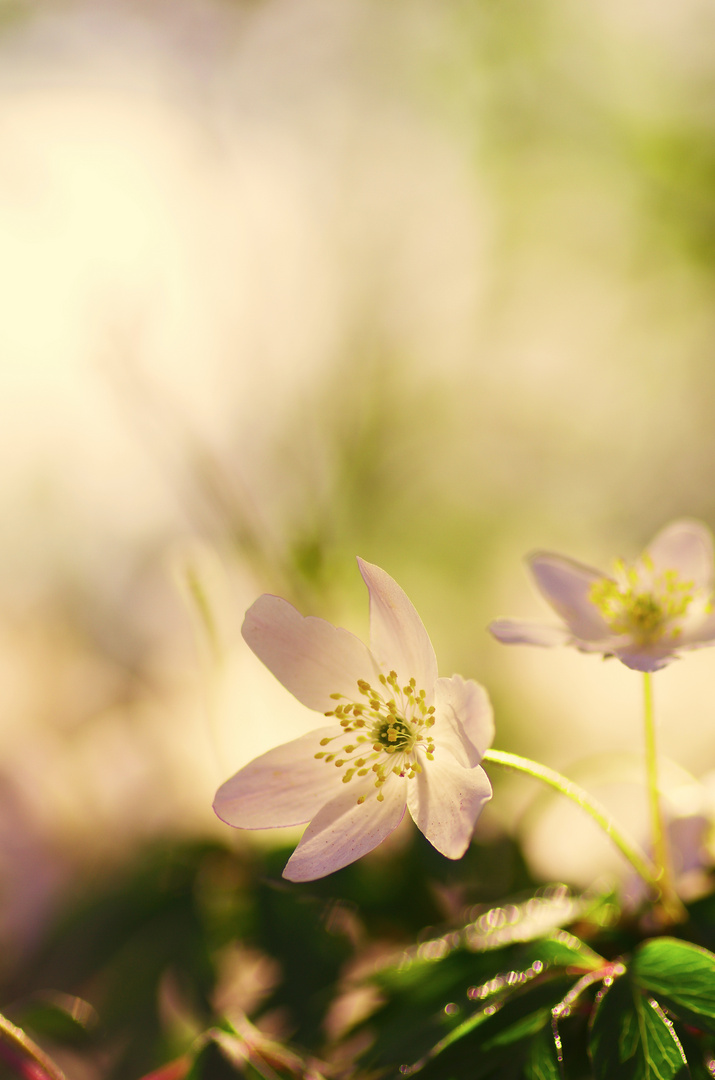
{"left": 0, "top": 0, "right": 715, "bottom": 1076}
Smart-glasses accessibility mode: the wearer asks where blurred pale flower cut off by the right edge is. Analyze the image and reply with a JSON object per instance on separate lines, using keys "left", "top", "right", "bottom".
{"left": 489, "top": 521, "right": 715, "bottom": 672}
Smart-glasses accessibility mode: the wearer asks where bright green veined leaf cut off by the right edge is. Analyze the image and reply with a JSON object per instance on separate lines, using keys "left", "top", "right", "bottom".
{"left": 631, "top": 937, "right": 715, "bottom": 1031}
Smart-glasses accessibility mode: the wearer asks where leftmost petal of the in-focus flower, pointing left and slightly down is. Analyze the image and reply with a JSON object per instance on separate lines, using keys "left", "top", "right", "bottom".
{"left": 214, "top": 726, "right": 343, "bottom": 828}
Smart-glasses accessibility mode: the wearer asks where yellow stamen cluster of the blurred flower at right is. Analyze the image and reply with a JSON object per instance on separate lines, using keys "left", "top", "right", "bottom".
{"left": 590, "top": 555, "right": 694, "bottom": 645}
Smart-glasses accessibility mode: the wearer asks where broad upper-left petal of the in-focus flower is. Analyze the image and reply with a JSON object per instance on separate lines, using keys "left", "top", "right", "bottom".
{"left": 241, "top": 594, "right": 377, "bottom": 713}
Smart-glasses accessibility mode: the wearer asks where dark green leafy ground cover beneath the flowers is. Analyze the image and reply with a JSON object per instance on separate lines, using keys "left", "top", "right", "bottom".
{"left": 0, "top": 837, "right": 715, "bottom": 1080}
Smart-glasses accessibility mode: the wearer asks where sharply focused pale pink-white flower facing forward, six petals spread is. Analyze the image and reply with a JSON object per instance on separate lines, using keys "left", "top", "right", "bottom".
{"left": 214, "top": 559, "right": 494, "bottom": 881}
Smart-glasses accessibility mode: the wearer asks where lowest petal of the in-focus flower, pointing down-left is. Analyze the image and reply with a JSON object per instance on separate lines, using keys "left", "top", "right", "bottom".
{"left": 283, "top": 777, "right": 407, "bottom": 881}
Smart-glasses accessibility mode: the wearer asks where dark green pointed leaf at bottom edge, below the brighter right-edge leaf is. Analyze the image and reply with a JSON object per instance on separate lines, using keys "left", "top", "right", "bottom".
{"left": 590, "top": 975, "right": 690, "bottom": 1080}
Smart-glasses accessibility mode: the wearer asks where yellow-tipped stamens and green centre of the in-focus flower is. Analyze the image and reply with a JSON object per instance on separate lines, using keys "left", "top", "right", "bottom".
{"left": 315, "top": 672, "right": 434, "bottom": 804}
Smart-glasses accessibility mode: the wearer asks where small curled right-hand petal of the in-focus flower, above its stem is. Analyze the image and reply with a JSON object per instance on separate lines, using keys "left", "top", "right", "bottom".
{"left": 434, "top": 675, "right": 494, "bottom": 768}
